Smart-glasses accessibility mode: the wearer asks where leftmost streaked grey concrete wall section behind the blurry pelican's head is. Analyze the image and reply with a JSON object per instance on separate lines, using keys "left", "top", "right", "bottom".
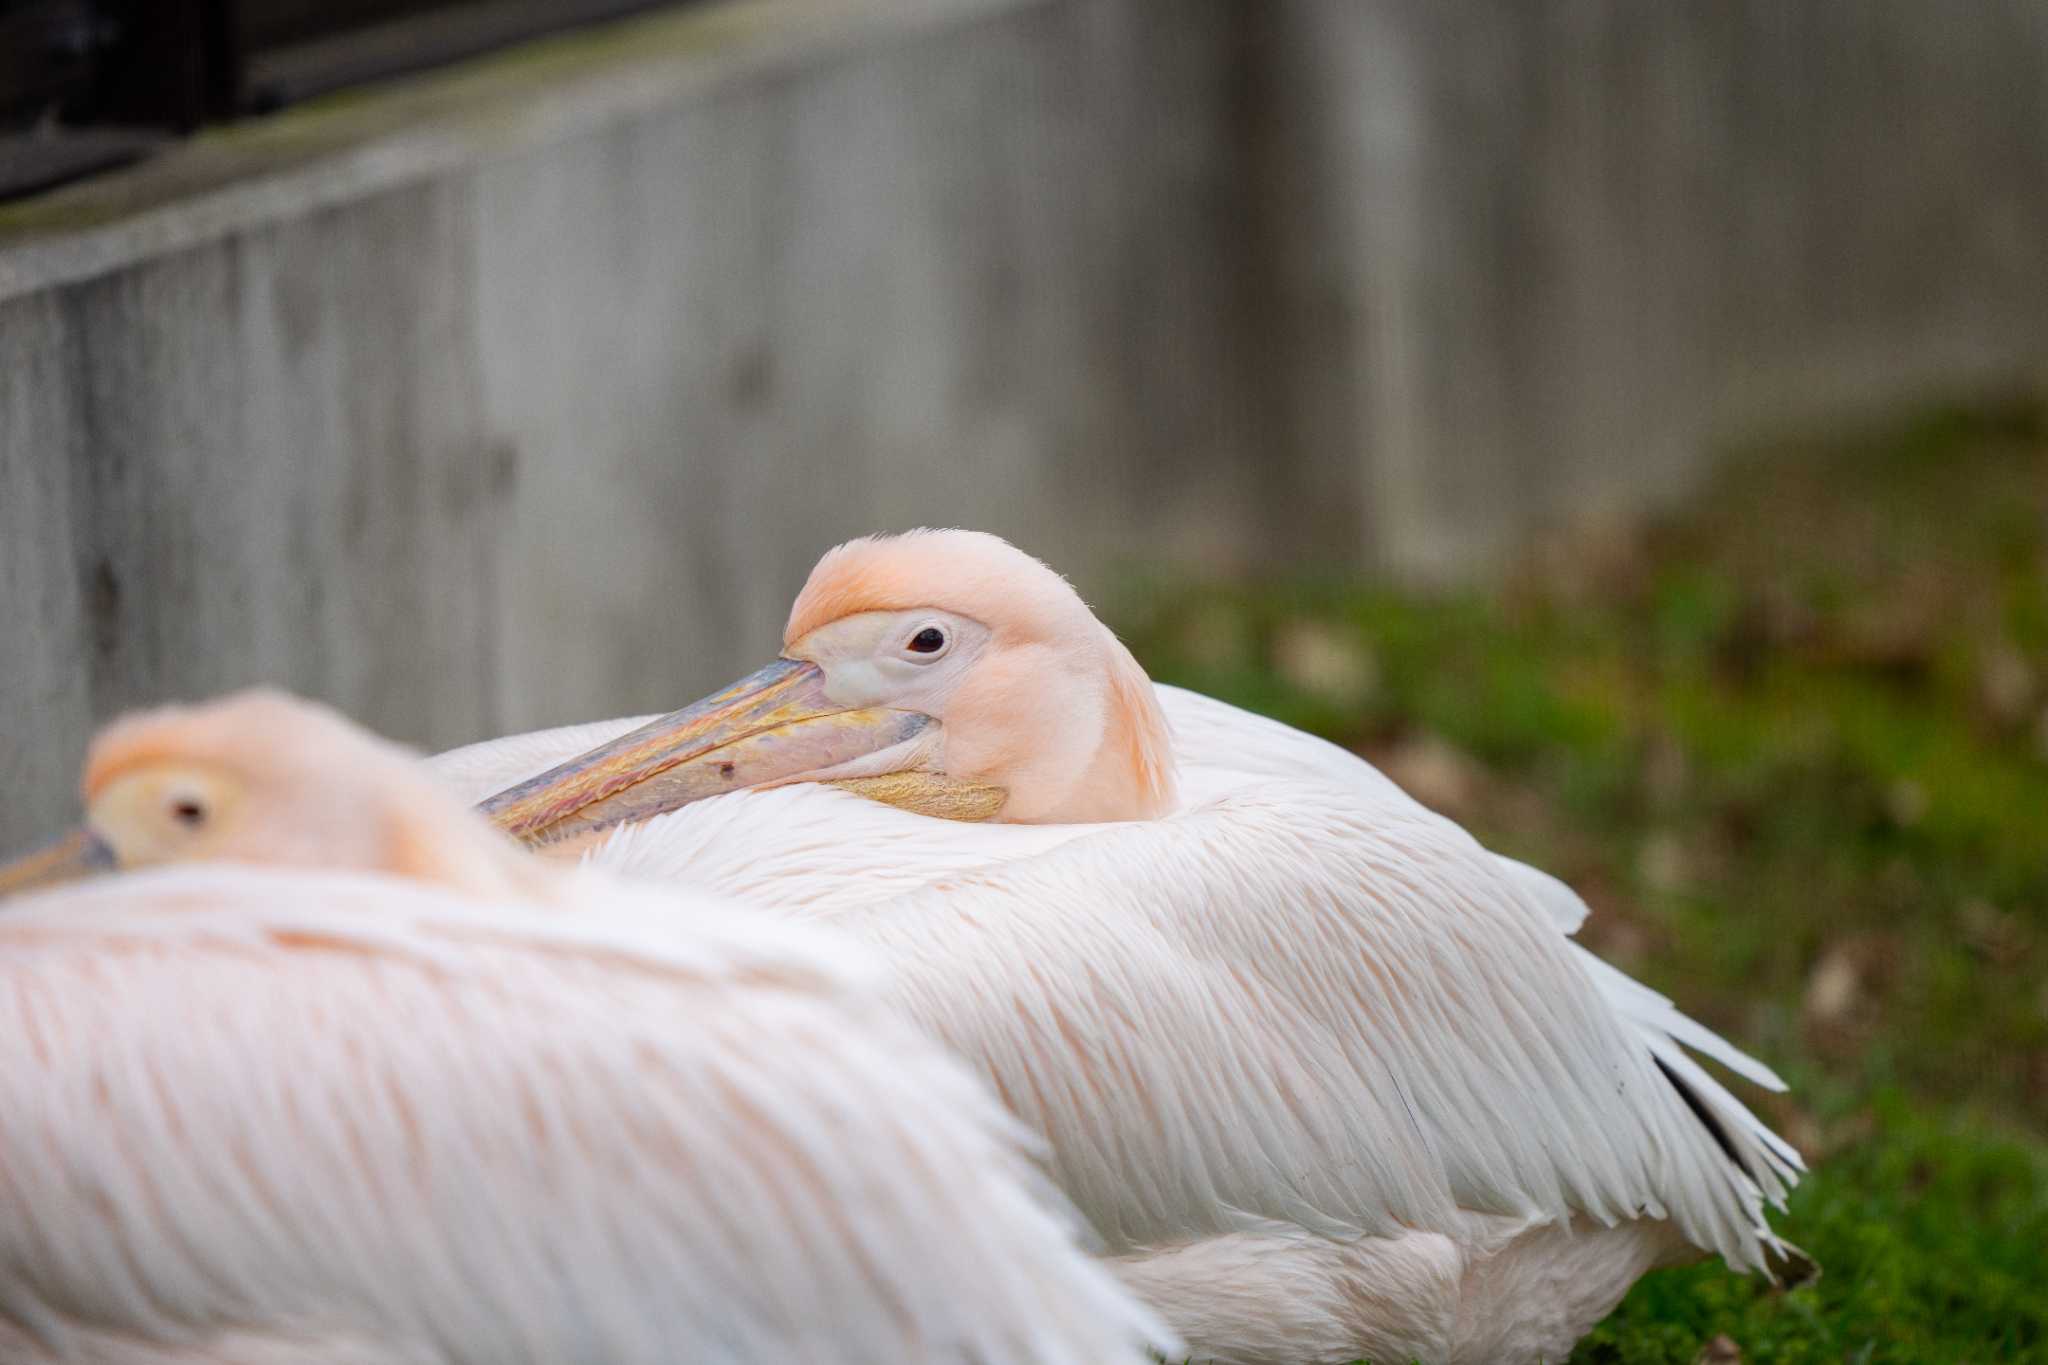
{"left": 0, "top": 184, "right": 502, "bottom": 841}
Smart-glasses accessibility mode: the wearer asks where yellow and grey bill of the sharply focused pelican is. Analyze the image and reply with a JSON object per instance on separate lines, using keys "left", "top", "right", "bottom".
{"left": 477, "top": 659, "right": 938, "bottom": 845}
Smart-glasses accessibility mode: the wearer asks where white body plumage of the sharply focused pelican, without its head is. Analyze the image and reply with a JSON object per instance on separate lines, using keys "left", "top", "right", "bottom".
{"left": 440, "top": 688, "right": 1800, "bottom": 1361}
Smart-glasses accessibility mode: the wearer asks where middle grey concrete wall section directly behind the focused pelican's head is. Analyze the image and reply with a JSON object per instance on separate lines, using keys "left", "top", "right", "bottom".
{"left": 477, "top": 0, "right": 1264, "bottom": 716}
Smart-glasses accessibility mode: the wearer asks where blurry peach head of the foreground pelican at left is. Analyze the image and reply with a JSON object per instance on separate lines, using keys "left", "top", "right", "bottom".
{"left": 0, "top": 692, "right": 537, "bottom": 894}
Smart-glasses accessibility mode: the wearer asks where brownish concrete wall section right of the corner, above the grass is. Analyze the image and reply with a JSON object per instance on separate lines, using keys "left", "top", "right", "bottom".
{"left": 1260, "top": 0, "right": 2048, "bottom": 573}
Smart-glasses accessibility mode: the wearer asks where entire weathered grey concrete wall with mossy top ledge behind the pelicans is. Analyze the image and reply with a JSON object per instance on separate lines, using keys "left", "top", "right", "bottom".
{"left": 0, "top": 0, "right": 2048, "bottom": 847}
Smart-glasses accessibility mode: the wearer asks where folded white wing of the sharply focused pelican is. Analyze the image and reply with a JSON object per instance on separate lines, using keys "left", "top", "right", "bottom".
{"left": 806, "top": 782, "right": 1784, "bottom": 1269}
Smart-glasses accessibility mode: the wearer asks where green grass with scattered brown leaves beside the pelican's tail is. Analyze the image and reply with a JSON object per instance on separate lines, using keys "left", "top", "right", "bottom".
{"left": 1114, "top": 401, "right": 2048, "bottom": 1365}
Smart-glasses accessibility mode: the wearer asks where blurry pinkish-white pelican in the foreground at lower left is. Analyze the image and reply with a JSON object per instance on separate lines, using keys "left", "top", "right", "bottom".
{"left": 0, "top": 694, "right": 1171, "bottom": 1365}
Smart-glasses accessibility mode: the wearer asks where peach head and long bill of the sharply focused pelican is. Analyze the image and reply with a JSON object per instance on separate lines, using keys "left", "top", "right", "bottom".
{"left": 479, "top": 530, "right": 1174, "bottom": 843}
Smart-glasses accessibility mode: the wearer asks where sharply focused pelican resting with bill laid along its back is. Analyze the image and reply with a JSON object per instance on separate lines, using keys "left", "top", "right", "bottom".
{"left": 438, "top": 530, "right": 1802, "bottom": 1365}
